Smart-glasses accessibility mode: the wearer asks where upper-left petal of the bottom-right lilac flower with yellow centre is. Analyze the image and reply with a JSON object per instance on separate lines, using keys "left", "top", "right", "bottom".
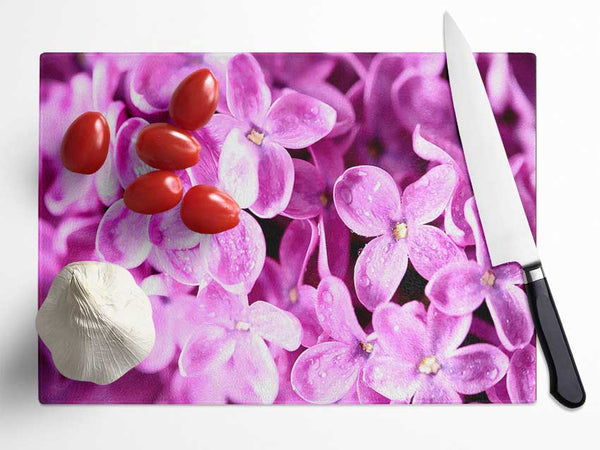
{"left": 373, "top": 302, "right": 429, "bottom": 366}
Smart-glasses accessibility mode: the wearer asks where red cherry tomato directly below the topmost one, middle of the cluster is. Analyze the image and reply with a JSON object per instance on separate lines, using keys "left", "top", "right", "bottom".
{"left": 136, "top": 123, "right": 200, "bottom": 170}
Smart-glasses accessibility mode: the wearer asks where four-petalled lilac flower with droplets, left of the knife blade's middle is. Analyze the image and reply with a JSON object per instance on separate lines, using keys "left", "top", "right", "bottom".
{"left": 333, "top": 165, "right": 465, "bottom": 310}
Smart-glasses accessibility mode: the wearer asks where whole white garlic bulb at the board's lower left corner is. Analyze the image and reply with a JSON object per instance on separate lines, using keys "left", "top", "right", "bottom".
{"left": 36, "top": 261, "right": 155, "bottom": 384}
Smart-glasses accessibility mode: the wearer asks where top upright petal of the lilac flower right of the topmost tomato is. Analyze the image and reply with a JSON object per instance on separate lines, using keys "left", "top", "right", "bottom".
{"left": 227, "top": 53, "right": 271, "bottom": 126}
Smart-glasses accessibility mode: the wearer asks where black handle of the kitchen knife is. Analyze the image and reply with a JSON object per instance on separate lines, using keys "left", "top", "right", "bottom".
{"left": 523, "top": 264, "right": 585, "bottom": 408}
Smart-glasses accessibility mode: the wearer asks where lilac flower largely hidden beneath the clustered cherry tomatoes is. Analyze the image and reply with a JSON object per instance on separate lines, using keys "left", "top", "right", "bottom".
{"left": 96, "top": 124, "right": 266, "bottom": 293}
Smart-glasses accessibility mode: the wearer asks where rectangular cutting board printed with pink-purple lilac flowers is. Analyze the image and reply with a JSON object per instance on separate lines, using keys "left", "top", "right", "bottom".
{"left": 39, "top": 54, "right": 536, "bottom": 404}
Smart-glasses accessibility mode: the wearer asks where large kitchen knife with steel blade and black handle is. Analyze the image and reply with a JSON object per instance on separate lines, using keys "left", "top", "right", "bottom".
{"left": 444, "top": 13, "right": 585, "bottom": 408}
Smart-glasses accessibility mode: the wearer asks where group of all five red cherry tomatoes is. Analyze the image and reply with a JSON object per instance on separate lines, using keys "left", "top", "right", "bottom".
{"left": 61, "top": 69, "right": 240, "bottom": 234}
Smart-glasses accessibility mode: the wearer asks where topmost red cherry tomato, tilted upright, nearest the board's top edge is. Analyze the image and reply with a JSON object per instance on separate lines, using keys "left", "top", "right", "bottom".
{"left": 169, "top": 69, "right": 219, "bottom": 130}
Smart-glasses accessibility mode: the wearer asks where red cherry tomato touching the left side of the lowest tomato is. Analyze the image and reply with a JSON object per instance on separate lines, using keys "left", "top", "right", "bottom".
{"left": 123, "top": 170, "right": 183, "bottom": 214}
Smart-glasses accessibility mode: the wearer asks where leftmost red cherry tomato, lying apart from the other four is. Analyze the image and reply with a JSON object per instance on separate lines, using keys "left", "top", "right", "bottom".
{"left": 60, "top": 111, "right": 110, "bottom": 175}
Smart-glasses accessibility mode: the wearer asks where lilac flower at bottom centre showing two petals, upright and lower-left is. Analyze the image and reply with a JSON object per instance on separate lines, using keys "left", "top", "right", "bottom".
{"left": 292, "top": 277, "right": 375, "bottom": 403}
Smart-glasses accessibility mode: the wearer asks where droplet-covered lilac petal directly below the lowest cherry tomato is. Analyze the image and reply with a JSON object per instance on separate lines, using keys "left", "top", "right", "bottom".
{"left": 201, "top": 211, "right": 266, "bottom": 293}
